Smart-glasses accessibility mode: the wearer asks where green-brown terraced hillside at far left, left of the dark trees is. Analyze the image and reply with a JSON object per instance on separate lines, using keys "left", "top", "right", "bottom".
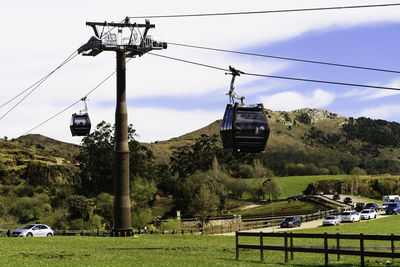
{"left": 0, "top": 135, "right": 80, "bottom": 185}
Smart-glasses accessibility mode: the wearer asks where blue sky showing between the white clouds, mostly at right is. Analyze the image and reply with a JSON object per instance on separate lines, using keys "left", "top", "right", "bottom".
{"left": 126, "top": 23, "right": 400, "bottom": 121}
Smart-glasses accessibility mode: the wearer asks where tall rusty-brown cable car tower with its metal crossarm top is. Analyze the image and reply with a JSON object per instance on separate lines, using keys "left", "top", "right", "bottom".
{"left": 78, "top": 17, "right": 167, "bottom": 237}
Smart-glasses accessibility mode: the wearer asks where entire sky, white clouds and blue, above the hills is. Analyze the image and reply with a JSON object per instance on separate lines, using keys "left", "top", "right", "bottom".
{"left": 0, "top": 0, "right": 400, "bottom": 144}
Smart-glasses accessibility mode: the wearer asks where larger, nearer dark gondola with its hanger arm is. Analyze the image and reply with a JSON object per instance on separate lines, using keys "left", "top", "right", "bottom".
{"left": 220, "top": 66, "right": 270, "bottom": 153}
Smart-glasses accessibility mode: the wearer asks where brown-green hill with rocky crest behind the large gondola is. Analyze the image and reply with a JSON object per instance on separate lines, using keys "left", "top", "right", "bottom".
{"left": 146, "top": 108, "right": 400, "bottom": 175}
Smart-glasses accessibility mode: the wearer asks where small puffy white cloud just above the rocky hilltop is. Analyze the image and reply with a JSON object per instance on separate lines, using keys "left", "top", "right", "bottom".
{"left": 260, "top": 89, "right": 335, "bottom": 111}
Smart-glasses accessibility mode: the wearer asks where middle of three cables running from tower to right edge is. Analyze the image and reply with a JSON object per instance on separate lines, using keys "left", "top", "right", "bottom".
{"left": 167, "top": 42, "right": 400, "bottom": 74}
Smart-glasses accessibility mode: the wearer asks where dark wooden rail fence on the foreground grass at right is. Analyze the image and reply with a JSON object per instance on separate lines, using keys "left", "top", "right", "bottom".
{"left": 236, "top": 232, "right": 400, "bottom": 266}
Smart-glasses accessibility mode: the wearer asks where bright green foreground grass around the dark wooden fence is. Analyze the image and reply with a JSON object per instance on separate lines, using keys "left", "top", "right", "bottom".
{"left": 0, "top": 216, "right": 400, "bottom": 266}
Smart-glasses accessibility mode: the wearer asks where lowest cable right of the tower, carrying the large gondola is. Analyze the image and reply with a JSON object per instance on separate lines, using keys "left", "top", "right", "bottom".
{"left": 148, "top": 53, "right": 400, "bottom": 91}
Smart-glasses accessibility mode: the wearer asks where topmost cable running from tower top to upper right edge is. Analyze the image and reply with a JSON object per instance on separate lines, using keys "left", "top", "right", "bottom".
{"left": 130, "top": 3, "right": 400, "bottom": 19}
